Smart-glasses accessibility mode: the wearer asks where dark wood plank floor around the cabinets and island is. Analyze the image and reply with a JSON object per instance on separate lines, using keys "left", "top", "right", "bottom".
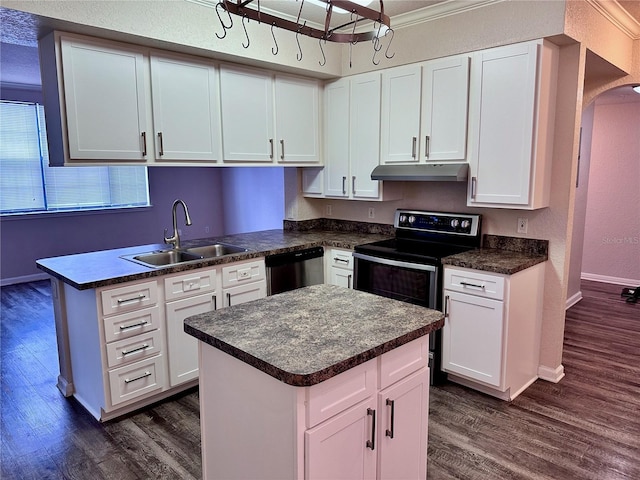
{"left": 0, "top": 282, "right": 640, "bottom": 480}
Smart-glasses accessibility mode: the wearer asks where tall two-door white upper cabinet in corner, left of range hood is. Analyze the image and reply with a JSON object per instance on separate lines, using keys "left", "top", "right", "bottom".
{"left": 324, "top": 73, "right": 401, "bottom": 200}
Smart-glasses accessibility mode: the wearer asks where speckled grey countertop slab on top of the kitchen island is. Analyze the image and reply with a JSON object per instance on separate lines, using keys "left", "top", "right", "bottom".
{"left": 184, "top": 285, "right": 444, "bottom": 386}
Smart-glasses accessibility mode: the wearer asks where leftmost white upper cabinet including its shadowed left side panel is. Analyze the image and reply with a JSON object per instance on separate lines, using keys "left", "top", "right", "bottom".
{"left": 40, "top": 32, "right": 154, "bottom": 165}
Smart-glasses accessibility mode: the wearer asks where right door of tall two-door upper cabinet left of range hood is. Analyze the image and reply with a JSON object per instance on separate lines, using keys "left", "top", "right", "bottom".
{"left": 349, "top": 73, "right": 380, "bottom": 198}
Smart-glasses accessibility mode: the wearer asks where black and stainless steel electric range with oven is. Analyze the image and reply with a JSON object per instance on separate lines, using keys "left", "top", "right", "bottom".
{"left": 353, "top": 209, "right": 482, "bottom": 384}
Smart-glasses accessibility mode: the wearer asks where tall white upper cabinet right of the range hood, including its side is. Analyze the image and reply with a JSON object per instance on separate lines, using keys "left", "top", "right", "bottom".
{"left": 467, "top": 41, "right": 558, "bottom": 209}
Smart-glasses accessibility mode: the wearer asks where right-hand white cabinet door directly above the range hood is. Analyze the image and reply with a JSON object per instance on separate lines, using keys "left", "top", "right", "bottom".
{"left": 420, "top": 56, "right": 469, "bottom": 162}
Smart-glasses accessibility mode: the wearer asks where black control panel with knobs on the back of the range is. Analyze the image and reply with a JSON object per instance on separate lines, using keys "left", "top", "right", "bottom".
{"left": 395, "top": 210, "right": 480, "bottom": 236}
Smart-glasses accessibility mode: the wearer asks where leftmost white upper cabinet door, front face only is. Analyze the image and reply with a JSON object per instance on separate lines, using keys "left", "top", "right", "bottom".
{"left": 61, "top": 37, "right": 152, "bottom": 160}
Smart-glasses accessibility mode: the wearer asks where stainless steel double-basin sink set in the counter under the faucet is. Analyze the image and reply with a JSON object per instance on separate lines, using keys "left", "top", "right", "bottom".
{"left": 121, "top": 243, "right": 249, "bottom": 268}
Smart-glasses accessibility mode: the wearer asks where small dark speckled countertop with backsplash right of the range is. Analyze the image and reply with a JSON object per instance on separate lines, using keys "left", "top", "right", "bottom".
{"left": 442, "top": 235, "right": 549, "bottom": 275}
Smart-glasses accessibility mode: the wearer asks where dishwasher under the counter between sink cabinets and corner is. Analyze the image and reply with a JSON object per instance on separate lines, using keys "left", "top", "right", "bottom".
{"left": 264, "top": 247, "right": 324, "bottom": 295}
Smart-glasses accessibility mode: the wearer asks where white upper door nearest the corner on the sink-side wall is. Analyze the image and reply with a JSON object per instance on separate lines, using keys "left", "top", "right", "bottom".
{"left": 275, "top": 76, "right": 320, "bottom": 163}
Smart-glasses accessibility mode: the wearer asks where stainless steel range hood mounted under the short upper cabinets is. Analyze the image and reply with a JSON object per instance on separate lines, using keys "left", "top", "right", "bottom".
{"left": 371, "top": 163, "right": 469, "bottom": 182}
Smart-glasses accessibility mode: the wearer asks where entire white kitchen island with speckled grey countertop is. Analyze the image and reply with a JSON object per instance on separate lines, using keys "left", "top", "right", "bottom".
{"left": 184, "top": 285, "right": 444, "bottom": 479}
